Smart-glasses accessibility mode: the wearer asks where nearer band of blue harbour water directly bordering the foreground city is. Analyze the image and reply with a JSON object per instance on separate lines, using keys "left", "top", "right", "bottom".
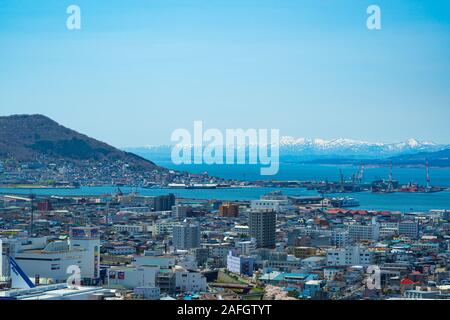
{"left": 0, "top": 187, "right": 450, "bottom": 212}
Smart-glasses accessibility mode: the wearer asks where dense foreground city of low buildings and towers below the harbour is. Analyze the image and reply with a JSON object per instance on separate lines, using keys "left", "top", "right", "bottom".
{"left": 0, "top": 178, "right": 450, "bottom": 300}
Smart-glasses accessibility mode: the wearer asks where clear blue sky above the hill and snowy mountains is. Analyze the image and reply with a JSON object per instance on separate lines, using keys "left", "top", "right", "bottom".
{"left": 0, "top": 0, "right": 450, "bottom": 147}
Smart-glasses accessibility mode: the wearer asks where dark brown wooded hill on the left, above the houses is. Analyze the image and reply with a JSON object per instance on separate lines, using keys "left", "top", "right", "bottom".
{"left": 0, "top": 115, "right": 162, "bottom": 170}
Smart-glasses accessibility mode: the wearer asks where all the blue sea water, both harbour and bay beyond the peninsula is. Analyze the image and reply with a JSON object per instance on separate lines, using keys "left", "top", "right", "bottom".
{"left": 0, "top": 164, "right": 450, "bottom": 212}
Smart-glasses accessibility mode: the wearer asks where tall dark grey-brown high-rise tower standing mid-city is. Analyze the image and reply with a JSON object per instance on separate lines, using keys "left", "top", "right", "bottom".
{"left": 249, "top": 210, "right": 277, "bottom": 248}
